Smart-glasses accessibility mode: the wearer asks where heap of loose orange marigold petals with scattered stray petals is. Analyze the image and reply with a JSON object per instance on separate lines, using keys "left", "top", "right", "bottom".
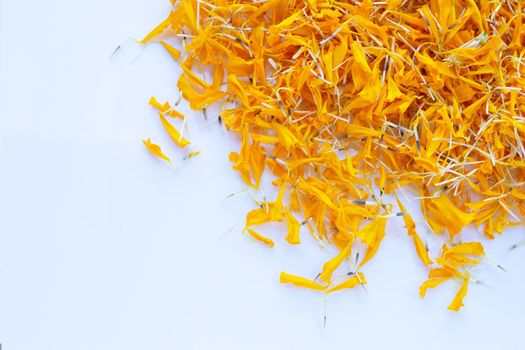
{"left": 141, "top": 0, "right": 525, "bottom": 311}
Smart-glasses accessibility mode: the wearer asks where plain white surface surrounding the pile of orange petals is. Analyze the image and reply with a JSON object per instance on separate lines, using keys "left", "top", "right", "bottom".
{"left": 0, "top": 0, "right": 525, "bottom": 350}
